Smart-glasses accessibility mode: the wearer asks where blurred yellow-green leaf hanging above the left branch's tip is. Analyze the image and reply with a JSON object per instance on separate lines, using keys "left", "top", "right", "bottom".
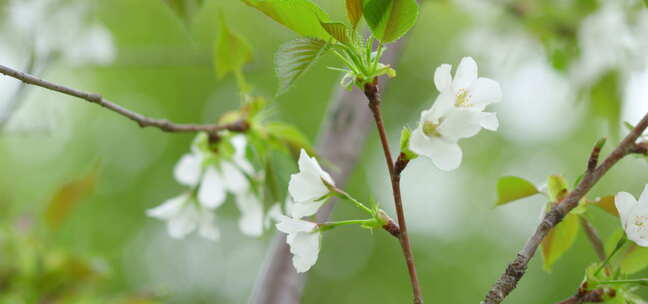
{"left": 214, "top": 14, "right": 252, "bottom": 78}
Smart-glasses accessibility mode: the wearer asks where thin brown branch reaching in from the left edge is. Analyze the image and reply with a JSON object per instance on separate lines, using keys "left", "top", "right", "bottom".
{"left": 0, "top": 65, "right": 249, "bottom": 133}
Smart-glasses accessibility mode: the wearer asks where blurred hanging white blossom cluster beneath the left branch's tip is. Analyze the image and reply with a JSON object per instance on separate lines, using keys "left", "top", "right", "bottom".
{"left": 147, "top": 133, "right": 278, "bottom": 240}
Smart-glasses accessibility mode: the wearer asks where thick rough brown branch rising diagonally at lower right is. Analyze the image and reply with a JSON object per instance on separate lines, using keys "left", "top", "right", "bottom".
{"left": 482, "top": 114, "right": 648, "bottom": 304}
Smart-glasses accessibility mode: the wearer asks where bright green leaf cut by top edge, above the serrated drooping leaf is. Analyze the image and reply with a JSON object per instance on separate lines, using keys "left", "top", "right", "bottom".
{"left": 242, "top": 0, "right": 331, "bottom": 40}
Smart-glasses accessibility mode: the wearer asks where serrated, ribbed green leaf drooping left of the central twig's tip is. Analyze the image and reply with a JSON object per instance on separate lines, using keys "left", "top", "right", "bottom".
{"left": 275, "top": 38, "right": 328, "bottom": 95}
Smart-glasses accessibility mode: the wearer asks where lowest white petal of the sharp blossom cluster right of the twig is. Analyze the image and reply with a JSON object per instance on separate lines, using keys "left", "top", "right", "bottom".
{"left": 409, "top": 127, "right": 462, "bottom": 171}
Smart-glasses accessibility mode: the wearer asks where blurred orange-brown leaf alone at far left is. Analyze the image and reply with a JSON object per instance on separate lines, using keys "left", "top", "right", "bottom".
{"left": 45, "top": 167, "right": 97, "bottom": 229}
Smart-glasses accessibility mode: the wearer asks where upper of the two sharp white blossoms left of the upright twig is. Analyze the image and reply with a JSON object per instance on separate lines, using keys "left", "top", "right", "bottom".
{"left": 287, "top": 149, "right": 335, "bottom": 219}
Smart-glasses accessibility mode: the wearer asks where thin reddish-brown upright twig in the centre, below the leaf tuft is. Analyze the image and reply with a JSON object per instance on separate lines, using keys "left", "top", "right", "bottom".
{"left": 364, "top": 79, "right": 423, "bottom": 304}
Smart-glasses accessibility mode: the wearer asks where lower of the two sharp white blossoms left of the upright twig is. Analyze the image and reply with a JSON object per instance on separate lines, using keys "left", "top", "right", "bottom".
{"left": 277, "top": 216, "right": 321, "bottom": 273}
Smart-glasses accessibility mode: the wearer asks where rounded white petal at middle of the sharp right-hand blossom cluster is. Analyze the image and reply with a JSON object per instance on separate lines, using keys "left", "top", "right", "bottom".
{"left": 437, "top": 110, "right": 482, "bottom": 141}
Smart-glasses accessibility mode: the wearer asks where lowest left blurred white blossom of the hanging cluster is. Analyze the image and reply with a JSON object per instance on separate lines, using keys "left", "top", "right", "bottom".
{"left": 146, "top": 193, "right": 220, "bottom": 241}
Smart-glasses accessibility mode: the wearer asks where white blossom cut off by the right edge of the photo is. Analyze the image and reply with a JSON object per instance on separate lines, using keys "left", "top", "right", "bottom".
{"left": 614, "top": 185, "right": 648, "bottom": 247}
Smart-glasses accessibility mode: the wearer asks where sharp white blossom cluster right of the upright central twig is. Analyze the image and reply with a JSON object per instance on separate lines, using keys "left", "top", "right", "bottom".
{"left": 409, "top": 57, "right": 502, "bottom": 171}
